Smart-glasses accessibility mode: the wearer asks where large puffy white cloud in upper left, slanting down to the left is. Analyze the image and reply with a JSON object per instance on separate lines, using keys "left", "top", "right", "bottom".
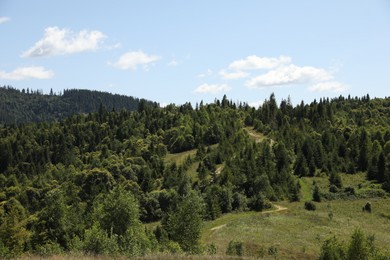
{"left": 22, "top": 27, "right": 106, "bottom": 57}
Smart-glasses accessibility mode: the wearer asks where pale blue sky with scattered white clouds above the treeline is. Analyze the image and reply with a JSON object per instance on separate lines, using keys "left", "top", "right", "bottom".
{"left": 0, "top": 0, "right": 390, "bottom": 105}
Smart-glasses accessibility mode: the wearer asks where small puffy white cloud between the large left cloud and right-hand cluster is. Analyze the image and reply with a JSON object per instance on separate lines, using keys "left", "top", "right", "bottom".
{"left": 113, "top": 51, "right": 161, "bottom": 70}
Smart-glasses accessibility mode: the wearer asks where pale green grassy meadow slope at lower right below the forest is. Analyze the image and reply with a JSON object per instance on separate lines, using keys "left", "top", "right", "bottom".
{"left": 202, "top": 173, "right": 390, "bottom": 259}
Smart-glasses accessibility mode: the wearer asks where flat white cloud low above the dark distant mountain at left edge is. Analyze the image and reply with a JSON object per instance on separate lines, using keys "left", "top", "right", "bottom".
{"left": 0, "top": 66, "right": 54, "bottom": 80}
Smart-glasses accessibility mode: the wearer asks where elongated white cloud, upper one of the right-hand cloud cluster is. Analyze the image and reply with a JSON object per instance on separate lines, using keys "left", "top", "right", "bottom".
{"left": 229, "top": 55, "right": 291, "bottom": 70}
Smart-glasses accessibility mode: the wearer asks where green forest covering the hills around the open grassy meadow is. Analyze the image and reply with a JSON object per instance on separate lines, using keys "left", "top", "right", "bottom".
{"left": 0, "top": 88, "right": 390, "bottom": 259}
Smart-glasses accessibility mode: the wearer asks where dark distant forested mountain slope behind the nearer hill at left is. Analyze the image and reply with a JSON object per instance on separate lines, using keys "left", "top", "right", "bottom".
{"left": 0, "top": 86, "right": 152, "bottom": 124}
